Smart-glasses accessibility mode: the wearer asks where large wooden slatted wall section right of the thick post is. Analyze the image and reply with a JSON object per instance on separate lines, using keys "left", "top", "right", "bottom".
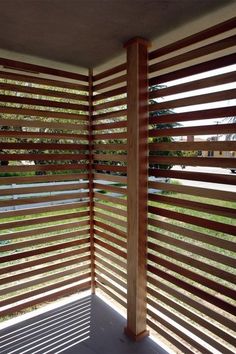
{"left": 148, "top": 19, "right": 236, "bottom": 353}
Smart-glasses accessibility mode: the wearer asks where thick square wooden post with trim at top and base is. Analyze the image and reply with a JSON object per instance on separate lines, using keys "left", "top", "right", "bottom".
{"left": 125, "top": 38, "right": 149, "bottom": 340}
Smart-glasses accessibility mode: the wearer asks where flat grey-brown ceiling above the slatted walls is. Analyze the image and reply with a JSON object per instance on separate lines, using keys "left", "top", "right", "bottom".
{"left": 0, "top": 0, "right": 232, "bottom": 67}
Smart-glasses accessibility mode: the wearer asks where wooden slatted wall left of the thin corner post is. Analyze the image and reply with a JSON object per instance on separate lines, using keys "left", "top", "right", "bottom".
{"left": 0, "top": 59, "right": 91, "bottom": 319}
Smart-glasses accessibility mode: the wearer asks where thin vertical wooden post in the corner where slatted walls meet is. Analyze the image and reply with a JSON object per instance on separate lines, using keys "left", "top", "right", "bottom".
{"left": 88, "top": 69, "right": 96, "bottom": 294}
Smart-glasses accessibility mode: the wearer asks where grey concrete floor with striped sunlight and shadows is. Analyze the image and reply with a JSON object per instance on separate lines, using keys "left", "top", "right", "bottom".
{"left": 0, "top": 295, "right": 167, "bottom": 354}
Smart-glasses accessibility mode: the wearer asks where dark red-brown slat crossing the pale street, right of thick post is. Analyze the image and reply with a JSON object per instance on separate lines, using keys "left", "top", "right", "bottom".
{"left": 149, "top": 168, "right": 236, "bottom": 185}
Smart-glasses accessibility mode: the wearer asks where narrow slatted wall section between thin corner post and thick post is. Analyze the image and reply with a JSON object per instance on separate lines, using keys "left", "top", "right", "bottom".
{"left": 93, "top": 64, "right": 127, "bottom": 306}
